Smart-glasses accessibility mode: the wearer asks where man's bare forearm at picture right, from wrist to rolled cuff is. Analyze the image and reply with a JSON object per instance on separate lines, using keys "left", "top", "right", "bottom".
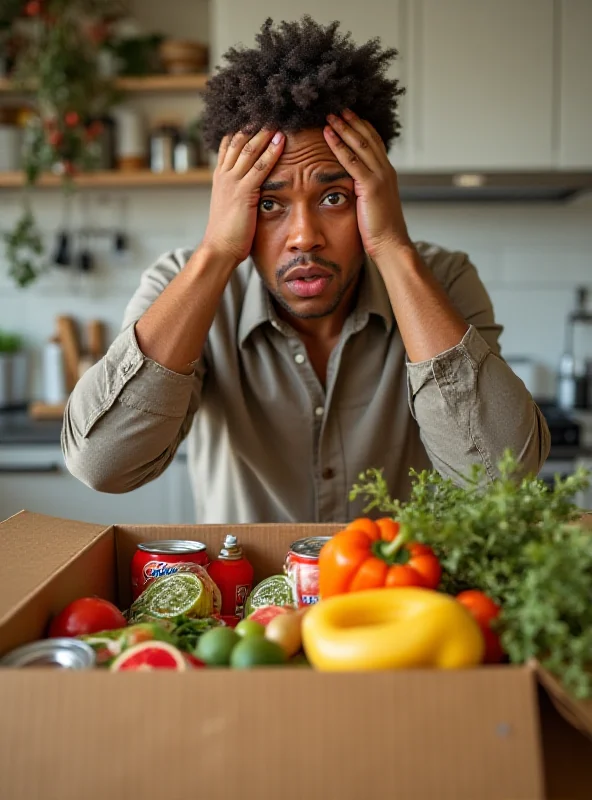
{"left": 375, "top": 245, "right": 469, "bottom": 362}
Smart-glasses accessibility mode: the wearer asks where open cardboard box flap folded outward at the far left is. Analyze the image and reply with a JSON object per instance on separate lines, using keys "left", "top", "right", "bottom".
{"left": 0, "top": 511, "right": 105, "bottom": 626}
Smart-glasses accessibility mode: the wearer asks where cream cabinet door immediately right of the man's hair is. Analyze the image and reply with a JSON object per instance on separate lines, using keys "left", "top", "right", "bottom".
{"left": 407, "top": 0, "right": 556, "bottom": 170}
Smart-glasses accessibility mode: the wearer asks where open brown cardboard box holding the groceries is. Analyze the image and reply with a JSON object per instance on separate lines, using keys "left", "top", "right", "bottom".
{"left": 0, "top": 512, "right": 592, "bottom": 800}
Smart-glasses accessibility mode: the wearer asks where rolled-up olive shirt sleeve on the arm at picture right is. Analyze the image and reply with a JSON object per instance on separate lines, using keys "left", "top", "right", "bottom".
{"left": 407, "top": 253, "right": 550, "bottom": 482}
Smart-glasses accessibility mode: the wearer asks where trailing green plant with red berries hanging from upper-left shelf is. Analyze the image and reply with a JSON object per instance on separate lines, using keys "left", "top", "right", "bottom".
{"left": 4, "top": 0, "right": 125, "bottom": 286}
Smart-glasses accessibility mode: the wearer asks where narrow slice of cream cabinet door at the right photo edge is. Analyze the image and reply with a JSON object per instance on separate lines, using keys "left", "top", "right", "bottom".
{"left": 559, "top": 0, "right": 592, "bottom": 169}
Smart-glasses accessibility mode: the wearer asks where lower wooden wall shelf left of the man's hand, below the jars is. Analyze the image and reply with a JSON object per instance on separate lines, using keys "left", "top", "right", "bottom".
{"left": 0, "top": 167, "right": 212, "bottom": 189}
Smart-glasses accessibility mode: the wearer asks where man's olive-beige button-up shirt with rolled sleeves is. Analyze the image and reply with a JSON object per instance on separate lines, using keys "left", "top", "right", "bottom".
{"left": 62, "top": 243, "right": 549, "bottom": 523}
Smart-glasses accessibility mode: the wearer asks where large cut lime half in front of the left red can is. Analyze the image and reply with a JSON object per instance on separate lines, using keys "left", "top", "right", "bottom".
{"left": 129, "top": 572, "right": 212, "bottom": 623}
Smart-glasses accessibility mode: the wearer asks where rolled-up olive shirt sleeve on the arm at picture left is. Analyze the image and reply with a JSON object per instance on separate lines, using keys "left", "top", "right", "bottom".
{"left": 61, "top": 253, "right": 205, "bottom": 493}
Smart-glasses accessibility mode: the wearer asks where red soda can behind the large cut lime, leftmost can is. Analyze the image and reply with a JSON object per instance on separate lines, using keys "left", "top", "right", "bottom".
{"left": 131, "top": 539, "right": 210, "bottom": 600}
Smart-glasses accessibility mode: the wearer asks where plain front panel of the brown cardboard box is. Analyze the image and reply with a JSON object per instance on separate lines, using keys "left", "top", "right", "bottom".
{"left": 0, "top": 667, "right": 543, "bottom": 800}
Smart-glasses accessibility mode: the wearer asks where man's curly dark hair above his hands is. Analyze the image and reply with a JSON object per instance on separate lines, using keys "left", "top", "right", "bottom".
{"left": 203, "top": 15, "right": 405, "bottom": 150}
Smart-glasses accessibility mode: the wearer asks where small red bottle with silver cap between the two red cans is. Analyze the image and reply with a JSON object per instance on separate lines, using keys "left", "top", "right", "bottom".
{"left": 208, "top": 534, "right": 254, "bottom": 627}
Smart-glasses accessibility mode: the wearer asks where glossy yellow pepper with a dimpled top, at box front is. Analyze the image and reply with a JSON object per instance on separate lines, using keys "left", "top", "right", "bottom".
{"left": 302, "top": 587, "right": 485, "bottom": 671}
